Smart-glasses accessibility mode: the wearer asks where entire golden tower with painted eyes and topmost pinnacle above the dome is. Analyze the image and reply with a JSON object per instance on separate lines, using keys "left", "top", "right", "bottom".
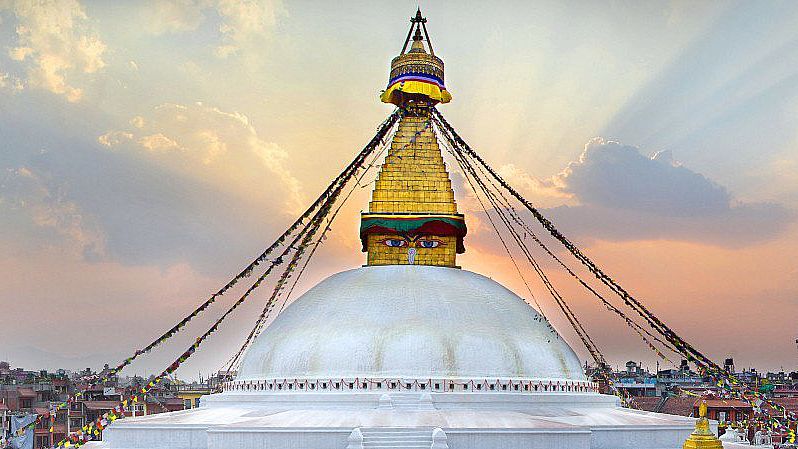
{"left": 360, "top": 11, "right": 466, "bottom": 267}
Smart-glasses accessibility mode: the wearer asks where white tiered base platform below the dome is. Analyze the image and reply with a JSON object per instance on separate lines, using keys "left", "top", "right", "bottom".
{"left": 85, "top": 391, "right": 694, "bottom": 449}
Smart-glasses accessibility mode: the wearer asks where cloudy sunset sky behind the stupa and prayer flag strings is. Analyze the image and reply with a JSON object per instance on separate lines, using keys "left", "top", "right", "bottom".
{"left": 0, "top": 0, "right": 798, "bottom": 378}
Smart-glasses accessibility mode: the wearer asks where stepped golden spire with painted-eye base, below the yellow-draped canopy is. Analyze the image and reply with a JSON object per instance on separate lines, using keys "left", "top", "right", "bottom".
{"left": 360, "top": 108, "right": 467, "bottom": 267}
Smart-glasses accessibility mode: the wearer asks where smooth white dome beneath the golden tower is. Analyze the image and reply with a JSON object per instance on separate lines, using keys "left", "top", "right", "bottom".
{"left": 237, "top": 265, "right": 585, "bottom": 381}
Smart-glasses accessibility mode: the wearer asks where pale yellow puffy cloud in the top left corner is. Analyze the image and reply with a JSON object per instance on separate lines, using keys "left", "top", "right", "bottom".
{"left": 0, "top": 0, "right": 106, "bottom": 102}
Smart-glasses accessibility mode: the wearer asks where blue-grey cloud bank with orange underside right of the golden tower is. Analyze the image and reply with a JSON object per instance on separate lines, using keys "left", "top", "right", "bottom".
{"left": 510, "top": 138, "right": 793, "bottom": 247}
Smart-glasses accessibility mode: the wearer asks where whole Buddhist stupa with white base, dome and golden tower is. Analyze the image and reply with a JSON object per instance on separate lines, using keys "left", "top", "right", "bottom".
{"left": 87, "top": 12, "right": 695, "bottom": 449}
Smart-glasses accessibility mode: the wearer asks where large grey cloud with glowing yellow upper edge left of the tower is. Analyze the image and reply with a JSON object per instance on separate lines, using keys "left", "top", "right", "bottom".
{"left": 0, "top": 96, "right": 307, "bottom": 276}
